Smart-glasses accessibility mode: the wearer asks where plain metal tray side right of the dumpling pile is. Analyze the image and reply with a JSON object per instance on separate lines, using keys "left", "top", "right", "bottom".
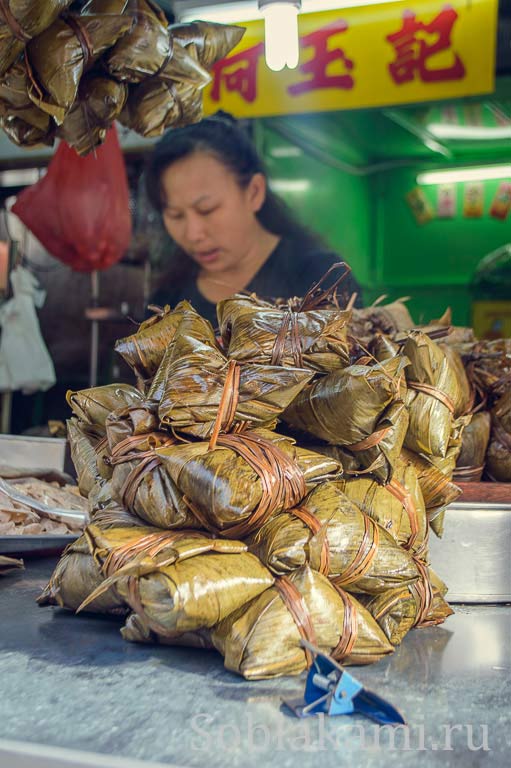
{"left": 430, "top": 502, "right": 511, "bottom": 603}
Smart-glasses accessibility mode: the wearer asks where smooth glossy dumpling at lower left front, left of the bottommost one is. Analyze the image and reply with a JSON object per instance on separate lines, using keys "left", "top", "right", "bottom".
{"left": 92, "top": 548, "right": 274, "bottom": 639}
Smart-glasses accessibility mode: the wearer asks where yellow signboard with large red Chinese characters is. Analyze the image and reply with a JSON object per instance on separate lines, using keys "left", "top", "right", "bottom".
{"left": 204, "top": 0, "right": 498, "bottom": 117}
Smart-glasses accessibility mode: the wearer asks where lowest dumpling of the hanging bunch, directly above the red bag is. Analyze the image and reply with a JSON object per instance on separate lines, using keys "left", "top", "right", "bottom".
{"left": 57, "top": 75, "right": 128, "bottom": 155}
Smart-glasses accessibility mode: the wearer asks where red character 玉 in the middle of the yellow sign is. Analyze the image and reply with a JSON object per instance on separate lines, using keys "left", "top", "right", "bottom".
{"left": 287, "top": 19, "right": 355, "bottom": 96}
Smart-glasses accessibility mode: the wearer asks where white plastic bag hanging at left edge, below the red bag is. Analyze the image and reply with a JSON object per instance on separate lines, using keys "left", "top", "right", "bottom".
{"left": 0, "top": 267, "right": 56, "bottom": 395}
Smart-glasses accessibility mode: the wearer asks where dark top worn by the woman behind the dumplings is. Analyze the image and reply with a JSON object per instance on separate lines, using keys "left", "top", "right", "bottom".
{"left": 151, "top": 238, "right": 362, "bottom": 326}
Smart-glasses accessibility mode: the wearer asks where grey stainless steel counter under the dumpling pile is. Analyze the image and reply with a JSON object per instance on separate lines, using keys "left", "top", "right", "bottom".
{"left": 0, "top": 559, "right": 511, "bottom": 768}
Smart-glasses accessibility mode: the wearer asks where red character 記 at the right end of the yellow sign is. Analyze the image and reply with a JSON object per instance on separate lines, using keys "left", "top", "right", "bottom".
{"left": 386, "top": 6, "right": 465, "bottom": 85}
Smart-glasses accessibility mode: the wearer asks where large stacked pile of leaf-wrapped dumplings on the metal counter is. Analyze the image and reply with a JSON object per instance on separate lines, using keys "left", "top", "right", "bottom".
{"left": 40, "top": 268, "right": 480, "bottom": 679}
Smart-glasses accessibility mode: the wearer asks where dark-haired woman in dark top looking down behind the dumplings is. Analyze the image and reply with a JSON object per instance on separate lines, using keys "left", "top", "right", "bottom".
{"left": 147, "top": 115, "right": 360, "bottom": 325}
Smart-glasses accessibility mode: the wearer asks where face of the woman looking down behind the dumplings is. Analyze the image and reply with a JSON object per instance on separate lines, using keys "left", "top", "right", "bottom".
{"left": 161, "top": 152, "right": 266, "bottom": 272}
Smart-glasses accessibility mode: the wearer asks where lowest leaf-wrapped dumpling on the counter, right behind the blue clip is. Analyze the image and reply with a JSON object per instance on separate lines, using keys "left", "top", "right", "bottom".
{"left": 211, "top": 567, "right": 393, "bottom": 680}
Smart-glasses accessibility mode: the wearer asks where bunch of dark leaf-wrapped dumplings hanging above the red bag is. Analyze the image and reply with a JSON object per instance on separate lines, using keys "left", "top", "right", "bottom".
{"left": 0, "top": 0, "right": 244, "bottom": 155}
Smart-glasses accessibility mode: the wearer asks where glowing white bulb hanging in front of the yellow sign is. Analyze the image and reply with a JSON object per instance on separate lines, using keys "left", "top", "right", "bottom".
{"left": 258, "top": 0, "right": 302, "bottom": 72}
